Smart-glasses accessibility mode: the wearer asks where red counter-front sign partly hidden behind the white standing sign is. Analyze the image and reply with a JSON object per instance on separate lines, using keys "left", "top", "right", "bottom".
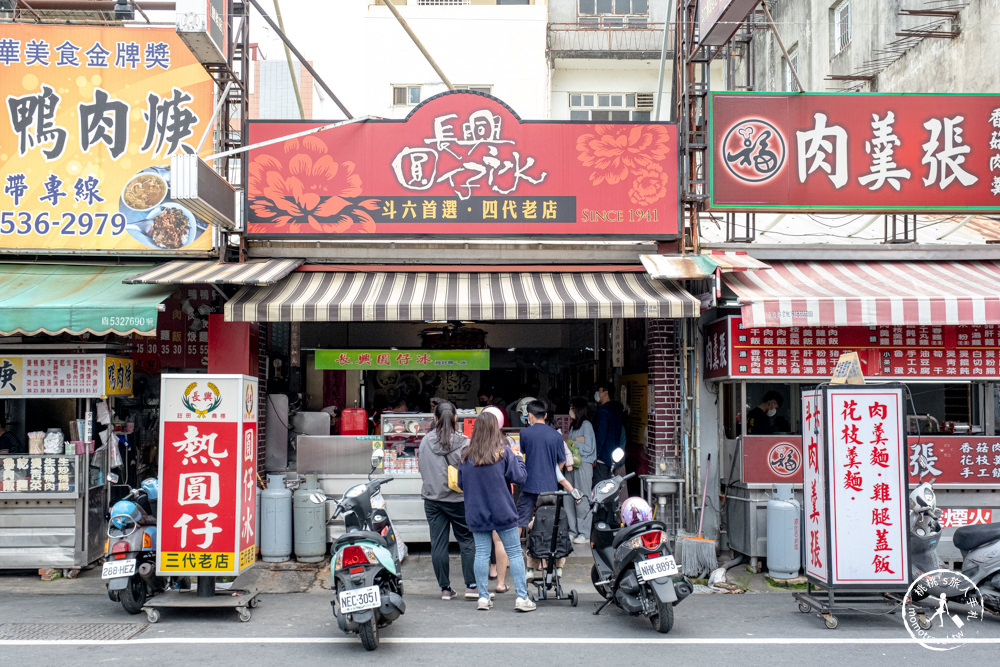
{"left": 741, "top": 436, "right": 1000, "bottom": 488}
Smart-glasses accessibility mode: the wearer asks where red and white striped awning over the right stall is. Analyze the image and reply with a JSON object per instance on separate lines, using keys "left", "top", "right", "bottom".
{"left": 722, "top": 261, "right": 1000, "bottom": 327}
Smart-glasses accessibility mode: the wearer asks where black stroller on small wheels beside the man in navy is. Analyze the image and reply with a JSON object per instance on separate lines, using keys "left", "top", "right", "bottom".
{"left": 527, "top": 491, "right": 580, "bottom": 607}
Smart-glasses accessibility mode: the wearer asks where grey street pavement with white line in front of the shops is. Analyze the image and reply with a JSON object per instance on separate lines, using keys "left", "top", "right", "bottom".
{"left": 0, "top": 554, "right": 1000, "bottom": 667}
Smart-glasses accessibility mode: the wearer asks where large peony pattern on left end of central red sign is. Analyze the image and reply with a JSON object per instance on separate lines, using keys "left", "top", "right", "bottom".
{"left": 249, "top": 136, "right": 379, "bottom": 234}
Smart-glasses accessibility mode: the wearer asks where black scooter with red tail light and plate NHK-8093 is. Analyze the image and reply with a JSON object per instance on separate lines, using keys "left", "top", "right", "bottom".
{"left": 590, "top": 449, "right": 694, "bottom": 633}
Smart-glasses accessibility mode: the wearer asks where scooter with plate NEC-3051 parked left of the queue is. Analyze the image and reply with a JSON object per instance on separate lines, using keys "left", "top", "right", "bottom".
{"left": 310, "top": 450, "right": 406, "bottom": 651}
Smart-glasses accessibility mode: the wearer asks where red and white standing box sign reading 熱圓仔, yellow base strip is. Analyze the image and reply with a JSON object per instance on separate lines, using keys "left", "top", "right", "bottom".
{"left": 156, "top": 374, "right": 257, "bottom": 576}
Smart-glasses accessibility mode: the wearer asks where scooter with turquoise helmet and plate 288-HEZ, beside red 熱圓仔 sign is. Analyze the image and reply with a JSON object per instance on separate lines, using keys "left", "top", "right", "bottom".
{"left": 101, "top": 477, "right": 172, "bottom": 614}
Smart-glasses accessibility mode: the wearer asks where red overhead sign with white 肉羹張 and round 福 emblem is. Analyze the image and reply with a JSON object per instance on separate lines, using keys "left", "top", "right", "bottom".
{"left": 709, "top": 93, "right": 1000, "bottom": 212}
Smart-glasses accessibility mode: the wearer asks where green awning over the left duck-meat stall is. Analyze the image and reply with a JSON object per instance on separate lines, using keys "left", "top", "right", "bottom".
{"left": 0, "top": 264, "right": 176, "bottom": 335}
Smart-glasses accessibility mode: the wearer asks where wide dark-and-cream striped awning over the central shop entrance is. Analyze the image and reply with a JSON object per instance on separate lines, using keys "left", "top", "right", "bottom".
{"left": 226, "top": 271, "right": 700, "bottom": 322}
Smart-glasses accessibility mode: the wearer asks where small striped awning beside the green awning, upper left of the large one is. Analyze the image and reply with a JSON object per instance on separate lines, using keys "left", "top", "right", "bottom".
{"left": 124, "top": 259, "right": 302, "bottom": 285}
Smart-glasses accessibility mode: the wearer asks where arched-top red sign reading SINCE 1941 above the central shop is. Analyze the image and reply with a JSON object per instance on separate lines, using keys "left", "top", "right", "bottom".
{"left": 247, "top": 92, "right": 679, "bottom": 238}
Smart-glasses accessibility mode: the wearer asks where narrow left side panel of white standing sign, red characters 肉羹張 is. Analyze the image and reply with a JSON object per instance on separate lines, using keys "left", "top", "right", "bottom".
{"left": 802, "top": 391, "right": 830, "bottom": 586}
